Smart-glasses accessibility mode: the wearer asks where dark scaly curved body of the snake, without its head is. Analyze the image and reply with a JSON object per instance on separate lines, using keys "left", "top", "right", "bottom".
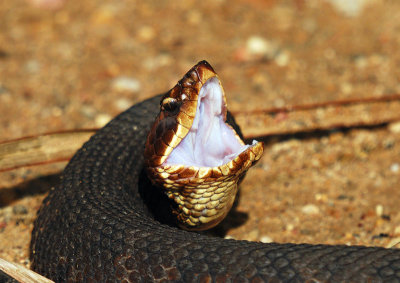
{"left": 31, "top": 61, "right": 400, "bottom": 282}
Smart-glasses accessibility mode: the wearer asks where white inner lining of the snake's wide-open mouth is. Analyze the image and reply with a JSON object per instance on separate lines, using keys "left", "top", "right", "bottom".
{"left": 164, "top": 77, "right": 254, "bottom": 167}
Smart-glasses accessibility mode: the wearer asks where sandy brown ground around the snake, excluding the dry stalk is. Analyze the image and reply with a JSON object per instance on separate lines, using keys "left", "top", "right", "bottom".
{"left": 0, "top": 0, "right": 400, "bottom": 270}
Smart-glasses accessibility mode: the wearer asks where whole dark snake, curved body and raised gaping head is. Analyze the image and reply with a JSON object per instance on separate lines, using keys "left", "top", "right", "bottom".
{"left": 30, "top": 61, "right": 400, "bottom": 282}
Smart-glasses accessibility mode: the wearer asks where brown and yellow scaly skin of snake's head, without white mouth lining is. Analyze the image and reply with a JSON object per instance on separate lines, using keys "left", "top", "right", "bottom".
{"left": 144, "top": 61, "right": 263, "bottom": 230}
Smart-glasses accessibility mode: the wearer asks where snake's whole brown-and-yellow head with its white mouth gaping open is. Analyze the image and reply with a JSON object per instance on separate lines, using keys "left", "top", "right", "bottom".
{"left": 144, "top": 61, "right": 263, "bottom": 230}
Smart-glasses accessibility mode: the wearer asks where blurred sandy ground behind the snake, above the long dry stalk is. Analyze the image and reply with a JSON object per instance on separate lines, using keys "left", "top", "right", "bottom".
{"left": 0, "top": 0, "right": 400, "bottom": 139}
